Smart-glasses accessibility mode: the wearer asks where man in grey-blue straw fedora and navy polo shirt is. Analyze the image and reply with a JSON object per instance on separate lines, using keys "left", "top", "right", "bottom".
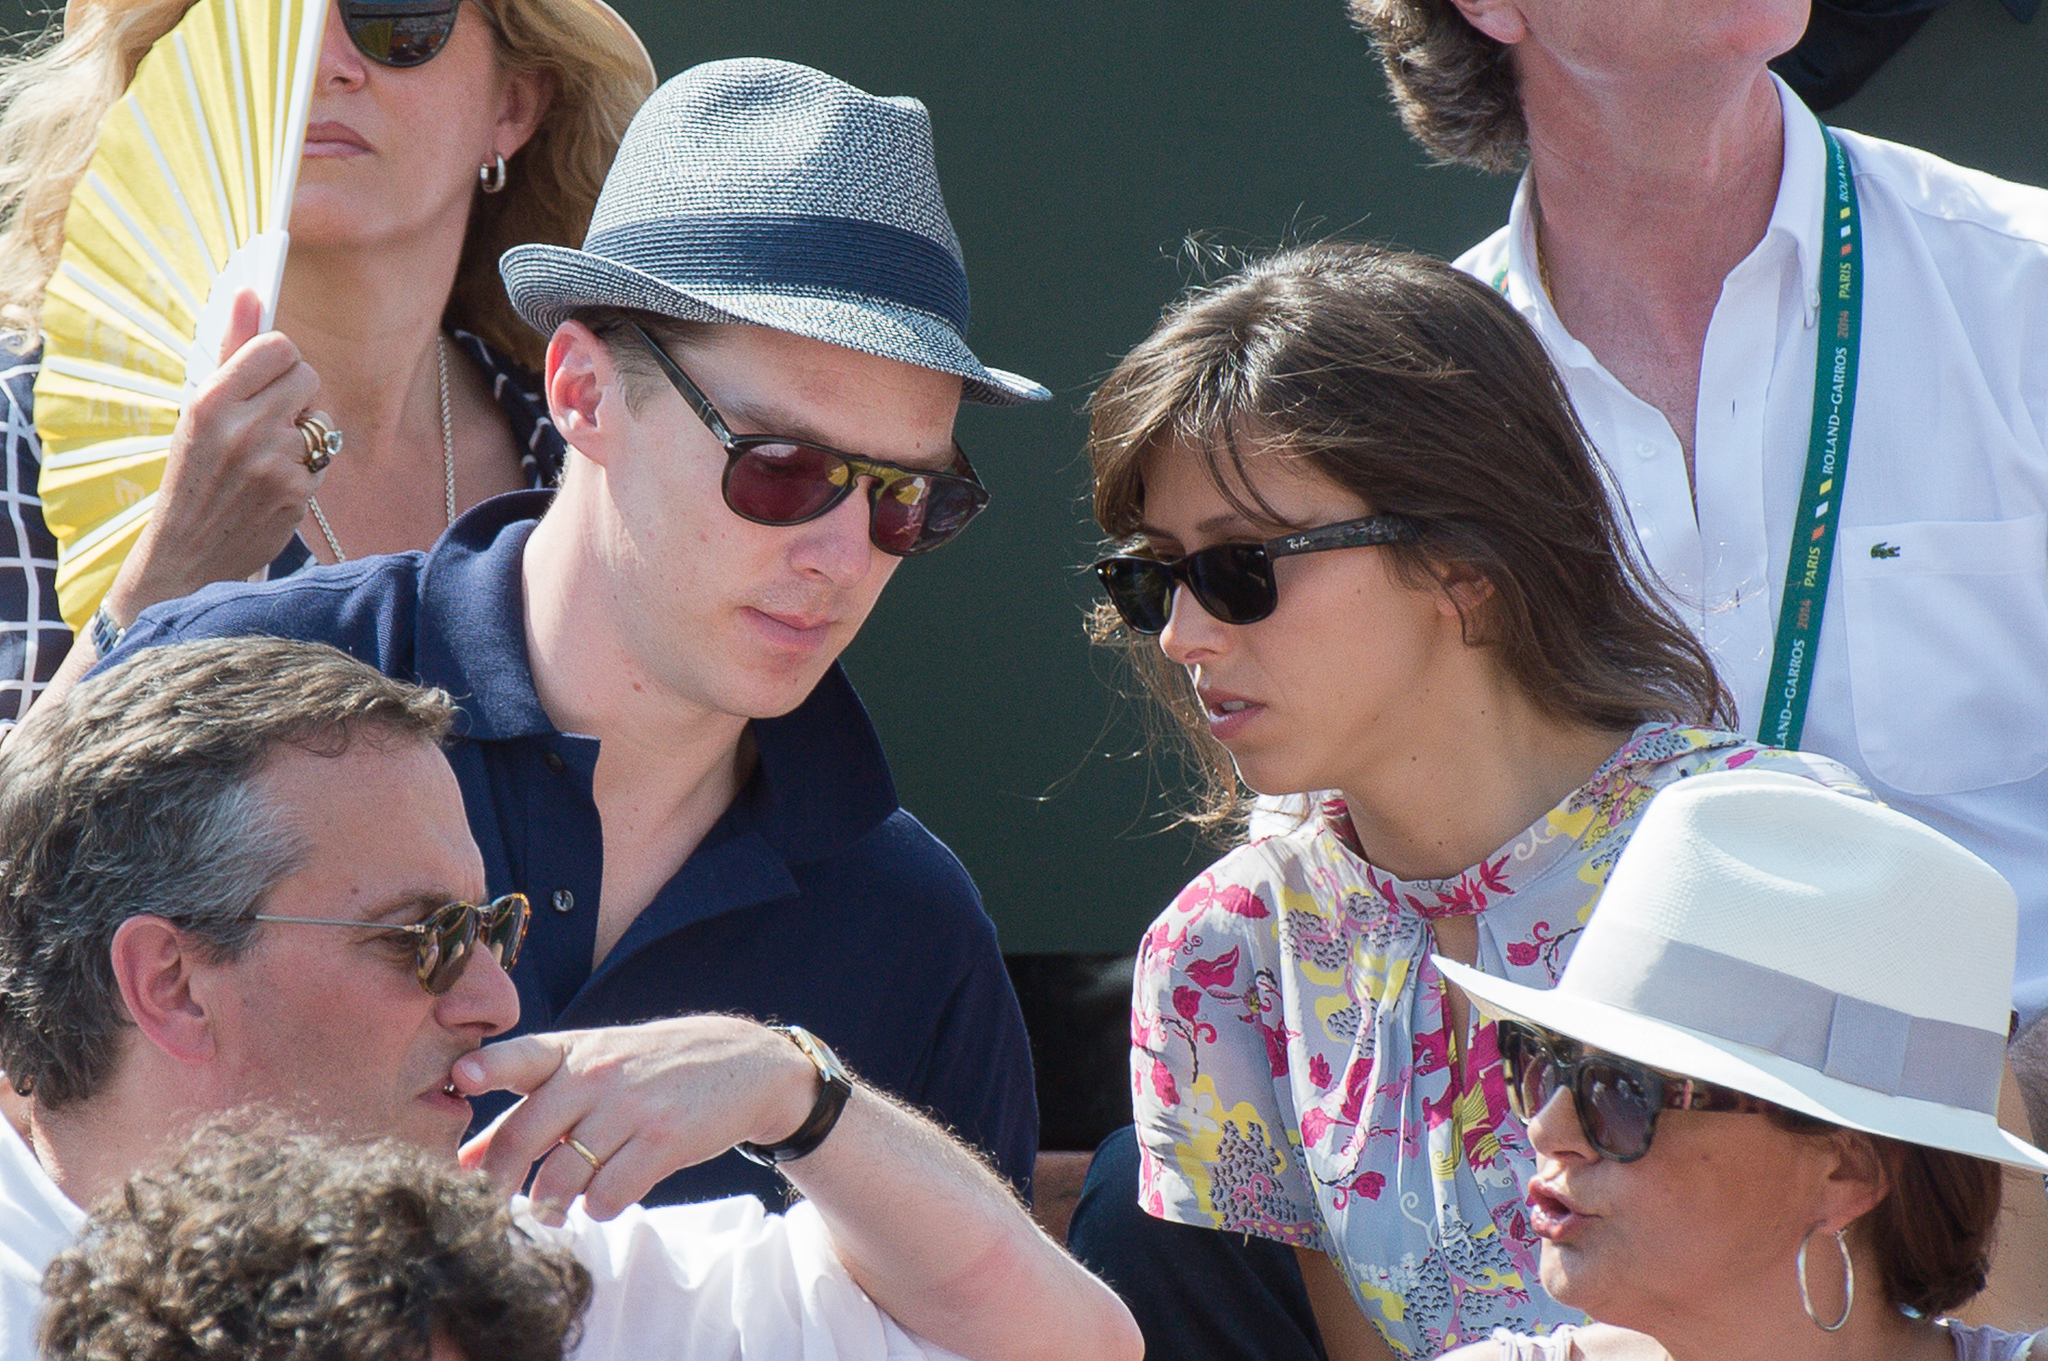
{"left": 97, "top": 59, "right": 1047, "bottom": 1201}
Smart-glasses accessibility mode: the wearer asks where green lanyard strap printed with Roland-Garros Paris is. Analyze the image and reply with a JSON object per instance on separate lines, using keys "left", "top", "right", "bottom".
{"left": 1757, "top": 125, "right": 1864, "bottom": 747}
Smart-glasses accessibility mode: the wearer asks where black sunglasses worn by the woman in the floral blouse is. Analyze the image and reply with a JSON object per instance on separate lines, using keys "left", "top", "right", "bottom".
{"left": 1096, "top": 516, "right": 1419, "bottom": 634}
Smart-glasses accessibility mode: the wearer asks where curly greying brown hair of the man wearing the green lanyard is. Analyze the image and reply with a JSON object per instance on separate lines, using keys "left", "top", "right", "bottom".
{"left": 1350, "top": 0, "right": 1528, "bottom": 172}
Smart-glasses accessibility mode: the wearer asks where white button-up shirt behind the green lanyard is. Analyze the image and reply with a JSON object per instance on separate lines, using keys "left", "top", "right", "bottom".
{"left": 1458, "top": 82, "right": 2048, "bottom": 1021}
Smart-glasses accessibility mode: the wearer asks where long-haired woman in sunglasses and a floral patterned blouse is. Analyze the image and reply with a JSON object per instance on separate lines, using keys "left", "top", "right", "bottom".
{"left": 1073, "top": 244, "right": 1858, "bottom": 1357}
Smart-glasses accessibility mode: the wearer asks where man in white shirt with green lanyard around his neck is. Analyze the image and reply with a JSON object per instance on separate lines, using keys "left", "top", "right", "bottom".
{"left": 1352, "top": 0, "right": 2048, "bottom": 1132}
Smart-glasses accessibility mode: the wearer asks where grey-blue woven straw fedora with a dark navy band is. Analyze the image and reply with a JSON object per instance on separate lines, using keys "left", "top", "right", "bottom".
{"left": 500, "top": 57, "right": 1051, "bottom": 405}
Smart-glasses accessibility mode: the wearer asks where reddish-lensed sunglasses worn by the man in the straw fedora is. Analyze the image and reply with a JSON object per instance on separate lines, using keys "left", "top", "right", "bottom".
{"left": 629, "top": 323, "right": 989, "bottom": 557}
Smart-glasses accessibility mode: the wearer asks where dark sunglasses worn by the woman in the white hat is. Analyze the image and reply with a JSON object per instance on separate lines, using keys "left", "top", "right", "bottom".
{"left": 1497, "top": 1021, "right": 1778, "bottom": 1162}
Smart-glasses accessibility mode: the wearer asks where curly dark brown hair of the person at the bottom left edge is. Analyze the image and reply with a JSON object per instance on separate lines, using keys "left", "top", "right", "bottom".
{"left": 41, "top": 1124, "right": 590, "bottom": 1361}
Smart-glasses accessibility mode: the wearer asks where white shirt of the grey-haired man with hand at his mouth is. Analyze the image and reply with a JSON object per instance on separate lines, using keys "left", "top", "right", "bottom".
{"left": 0, "top": 1119, "right": 958, "bottom": 1361}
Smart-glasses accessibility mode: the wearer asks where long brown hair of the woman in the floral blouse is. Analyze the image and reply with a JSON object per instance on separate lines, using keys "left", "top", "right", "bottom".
{"left": 1087, "top": 242, "right": 1733, "bottom": 829}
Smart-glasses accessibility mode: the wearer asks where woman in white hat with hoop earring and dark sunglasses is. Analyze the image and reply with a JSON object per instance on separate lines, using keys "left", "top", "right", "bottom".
{"left": 1442, "top": 772, "right": 2048, "bottom": 1361}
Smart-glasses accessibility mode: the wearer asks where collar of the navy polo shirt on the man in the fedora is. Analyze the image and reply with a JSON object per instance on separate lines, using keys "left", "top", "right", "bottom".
{"left": 414, "top": 491, "right": 897, "bottom": 864}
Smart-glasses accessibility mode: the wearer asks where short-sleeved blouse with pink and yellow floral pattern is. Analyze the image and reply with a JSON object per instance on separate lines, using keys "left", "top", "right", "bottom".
{"left": 1130, "top": 725, "right": 1868, "bottom": 1357}
